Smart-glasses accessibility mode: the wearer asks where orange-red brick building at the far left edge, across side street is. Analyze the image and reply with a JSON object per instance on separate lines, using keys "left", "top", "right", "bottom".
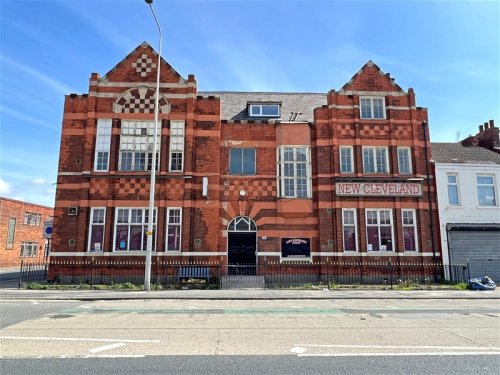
{"left": 0, "top": 198, "right": 54, "bottom": 268}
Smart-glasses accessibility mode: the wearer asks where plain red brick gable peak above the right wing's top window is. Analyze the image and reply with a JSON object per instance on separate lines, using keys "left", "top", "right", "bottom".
{"left": 341, "top": 60, "right": 405, "bottom": 92}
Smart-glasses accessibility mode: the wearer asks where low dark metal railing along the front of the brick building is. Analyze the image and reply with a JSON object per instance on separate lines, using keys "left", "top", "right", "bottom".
{"left": 19, "top": 257, "right": 470, "bottom": 289}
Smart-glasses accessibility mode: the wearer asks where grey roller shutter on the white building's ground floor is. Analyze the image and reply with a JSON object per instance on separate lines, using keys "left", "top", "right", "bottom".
{"left": 448, "top": 230, "right": 500, "bottom": 285}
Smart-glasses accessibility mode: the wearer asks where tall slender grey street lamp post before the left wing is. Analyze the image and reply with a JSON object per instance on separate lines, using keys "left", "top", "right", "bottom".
{"left": 144, "top": 0, "right": 162, "bottom": 292}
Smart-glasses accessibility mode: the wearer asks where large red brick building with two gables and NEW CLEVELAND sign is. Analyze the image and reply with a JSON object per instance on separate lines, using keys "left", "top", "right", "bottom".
{"left": 52, "top": 43, "right": 440, "bottom": 280}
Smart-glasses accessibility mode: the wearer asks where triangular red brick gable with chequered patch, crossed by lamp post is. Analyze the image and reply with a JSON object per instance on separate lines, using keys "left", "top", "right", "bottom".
{"left": 101, "top": 42, "right": 185, "bottom": 82}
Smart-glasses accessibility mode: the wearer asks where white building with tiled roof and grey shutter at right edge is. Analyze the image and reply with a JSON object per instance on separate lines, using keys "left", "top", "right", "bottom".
{"left": 431, "top": 129, "right": 500, "bottom": 282}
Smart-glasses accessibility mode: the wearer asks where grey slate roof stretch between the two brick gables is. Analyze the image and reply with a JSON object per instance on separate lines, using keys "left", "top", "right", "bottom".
{"left": 198, "top": 91, "right": 327, "bottom": 122}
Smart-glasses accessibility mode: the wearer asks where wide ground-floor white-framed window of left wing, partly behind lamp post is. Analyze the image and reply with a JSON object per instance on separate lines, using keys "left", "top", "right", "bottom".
{"left": 113, "top": 207, "right": 157, "bottom": 251}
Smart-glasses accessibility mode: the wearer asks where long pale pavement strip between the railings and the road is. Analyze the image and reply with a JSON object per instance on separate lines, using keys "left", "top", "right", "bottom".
{"left": 0, "top": 288, "right": 500, "bottom": 301}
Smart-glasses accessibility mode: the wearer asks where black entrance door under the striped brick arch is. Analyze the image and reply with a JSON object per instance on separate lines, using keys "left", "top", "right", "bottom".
{"left": 227, "top": 232, "right": 257, "bottom": 275}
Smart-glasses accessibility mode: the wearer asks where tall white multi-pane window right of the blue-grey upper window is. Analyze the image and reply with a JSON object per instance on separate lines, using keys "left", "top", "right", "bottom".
{"left": 277, "top": 146, "right": 311, "bottom": 198}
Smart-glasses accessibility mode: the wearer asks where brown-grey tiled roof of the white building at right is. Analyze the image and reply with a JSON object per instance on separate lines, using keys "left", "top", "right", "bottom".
{"left": 431, "top": 142, "right": 500, "bottom": 165}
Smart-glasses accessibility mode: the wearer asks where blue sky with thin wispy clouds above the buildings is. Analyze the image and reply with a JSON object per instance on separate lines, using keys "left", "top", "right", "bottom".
{"left": 0, "top": 0, "right": 500, "bottom": 206}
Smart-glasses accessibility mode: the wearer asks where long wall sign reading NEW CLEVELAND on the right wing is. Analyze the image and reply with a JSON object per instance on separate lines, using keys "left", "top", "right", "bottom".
{"left": 335, "top": 182, "right": 422, "bottom": 197}
